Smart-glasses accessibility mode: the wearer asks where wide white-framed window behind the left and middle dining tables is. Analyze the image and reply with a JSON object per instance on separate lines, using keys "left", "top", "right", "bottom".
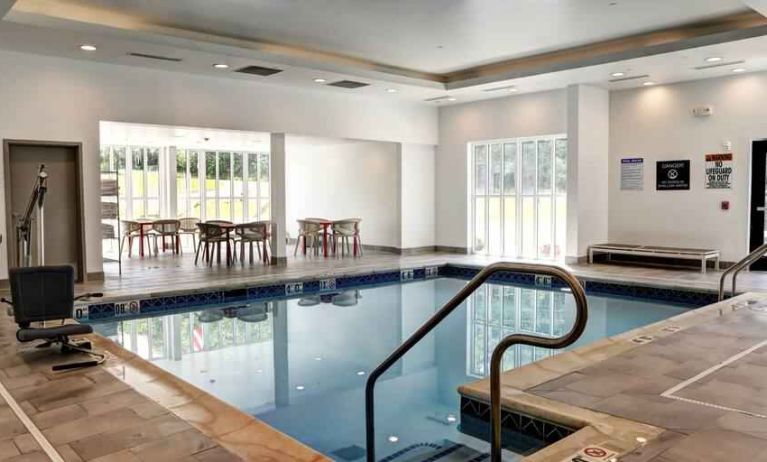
{"left": 101, "top": 145, "right": 271, "bottom": 222}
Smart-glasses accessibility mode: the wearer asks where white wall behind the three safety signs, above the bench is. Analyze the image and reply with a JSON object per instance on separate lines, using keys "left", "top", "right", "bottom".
{"left": 609, "top": 73, "right": 767, "bottom": 261}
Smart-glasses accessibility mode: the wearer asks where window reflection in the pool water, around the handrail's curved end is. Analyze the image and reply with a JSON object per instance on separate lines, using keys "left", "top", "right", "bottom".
{"left": 467, "top": 284, "right": 572, "bottom": 378}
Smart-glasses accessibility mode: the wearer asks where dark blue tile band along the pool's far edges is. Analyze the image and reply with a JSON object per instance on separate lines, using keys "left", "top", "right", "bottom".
{"left": 81, "top": 264, "right": 717, "bottom": 321}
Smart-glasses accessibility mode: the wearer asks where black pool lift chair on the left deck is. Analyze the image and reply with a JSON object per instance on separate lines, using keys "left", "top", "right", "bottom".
{"left": 0, "top": 266, "right": 106, "bottom": 371}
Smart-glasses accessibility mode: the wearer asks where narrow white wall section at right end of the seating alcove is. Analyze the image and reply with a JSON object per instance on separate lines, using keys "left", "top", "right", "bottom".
{"left": 398, "top": 143, "right": 436, "bottom": 249}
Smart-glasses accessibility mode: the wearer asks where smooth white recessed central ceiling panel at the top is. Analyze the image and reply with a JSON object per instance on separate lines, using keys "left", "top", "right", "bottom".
{"left": 36, "top": 0, "right": 747, "bottom": 73}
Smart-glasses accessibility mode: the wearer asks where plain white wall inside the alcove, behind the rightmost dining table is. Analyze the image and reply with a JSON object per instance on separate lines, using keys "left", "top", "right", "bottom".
{"left": 286, "top": 138, "right": 400, "bottom": 247}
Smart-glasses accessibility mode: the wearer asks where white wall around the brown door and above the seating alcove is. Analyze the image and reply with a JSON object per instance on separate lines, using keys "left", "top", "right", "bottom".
{"left": 0, "top": 51, "right": 437, "bottom": 278}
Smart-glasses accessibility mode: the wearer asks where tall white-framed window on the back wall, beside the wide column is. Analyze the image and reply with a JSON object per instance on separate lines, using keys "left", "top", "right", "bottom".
{"left": 469, "top": 135, "right": 567, "bottom": 259}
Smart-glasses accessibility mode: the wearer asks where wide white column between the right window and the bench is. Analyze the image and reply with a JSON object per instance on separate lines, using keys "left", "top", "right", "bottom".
{"left": 567, "top": 85, "right": 610, "bottom": 263}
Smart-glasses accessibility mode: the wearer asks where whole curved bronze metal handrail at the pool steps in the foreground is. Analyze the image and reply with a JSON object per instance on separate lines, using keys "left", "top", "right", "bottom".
{"left": 365, "top": 262, "right": 588, "bottom": 462}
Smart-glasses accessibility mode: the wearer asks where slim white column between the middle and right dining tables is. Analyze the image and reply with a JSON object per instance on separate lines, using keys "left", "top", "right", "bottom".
{"left": 270, "top": 133, "right": 287, "bottom": 264}
